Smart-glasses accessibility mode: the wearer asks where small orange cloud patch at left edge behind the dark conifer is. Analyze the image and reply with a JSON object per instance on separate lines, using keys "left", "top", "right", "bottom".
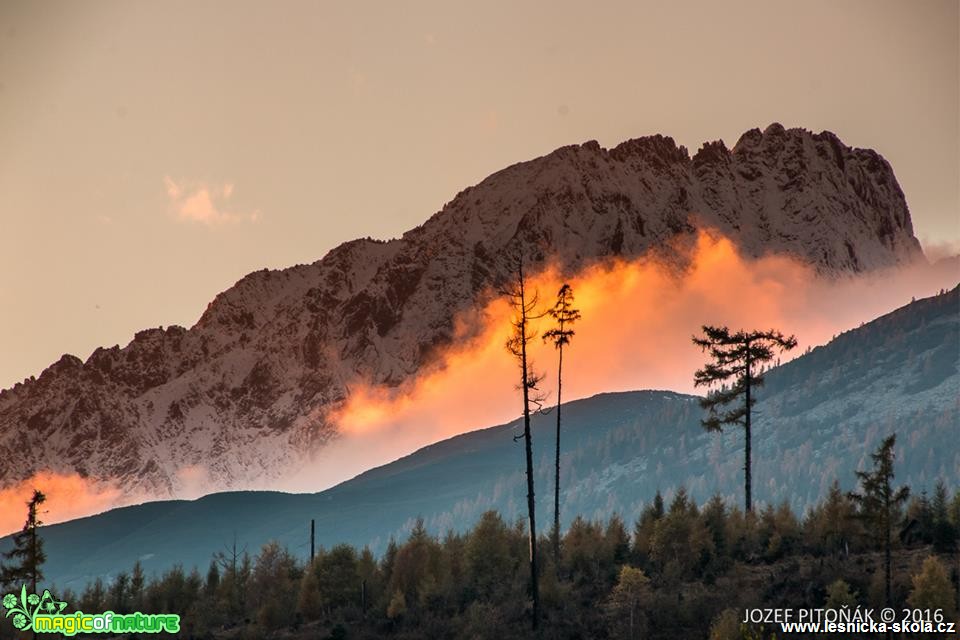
{"left": 0, "top": 471, "right": 131, "bottom": 536}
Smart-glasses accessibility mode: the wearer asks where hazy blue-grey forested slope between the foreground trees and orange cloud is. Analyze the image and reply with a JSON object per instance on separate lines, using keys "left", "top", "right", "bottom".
{"left": 11, "top": 288, "right": 960, "bottom": 586}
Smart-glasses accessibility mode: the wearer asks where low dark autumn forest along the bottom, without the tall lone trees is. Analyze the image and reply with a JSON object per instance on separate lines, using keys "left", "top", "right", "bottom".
{"left": 16, "top": 482, "right": 960, "bottom": 640}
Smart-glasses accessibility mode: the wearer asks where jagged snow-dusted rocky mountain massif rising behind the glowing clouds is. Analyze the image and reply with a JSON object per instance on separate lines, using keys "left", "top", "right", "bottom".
{"left": 0, "top": 124, "right": 923, "bottom": 496}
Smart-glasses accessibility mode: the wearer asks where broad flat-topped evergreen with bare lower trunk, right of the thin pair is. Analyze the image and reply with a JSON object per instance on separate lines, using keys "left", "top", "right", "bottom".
{"left": 693, "top": 325, "right": 797, "bottom": 511}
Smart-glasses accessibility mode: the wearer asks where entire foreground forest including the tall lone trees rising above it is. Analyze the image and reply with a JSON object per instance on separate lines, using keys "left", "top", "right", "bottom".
{"left": 0, "top": 286, "right": 960, "bottom": 640}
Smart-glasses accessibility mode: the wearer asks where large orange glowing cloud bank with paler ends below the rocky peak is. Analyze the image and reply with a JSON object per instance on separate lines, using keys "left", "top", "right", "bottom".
{"left": 287, "top": 231, "right": 956, "bottom": 488}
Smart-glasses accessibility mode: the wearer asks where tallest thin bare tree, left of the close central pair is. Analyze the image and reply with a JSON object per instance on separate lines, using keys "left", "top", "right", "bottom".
{"left": 503, "top": 251, "right": 544, "bottom": 630}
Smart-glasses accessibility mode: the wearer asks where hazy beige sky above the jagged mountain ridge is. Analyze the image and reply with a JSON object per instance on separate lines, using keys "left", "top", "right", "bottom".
{"left": 0, "top": 0, "right": 960, "bottom": 388}
